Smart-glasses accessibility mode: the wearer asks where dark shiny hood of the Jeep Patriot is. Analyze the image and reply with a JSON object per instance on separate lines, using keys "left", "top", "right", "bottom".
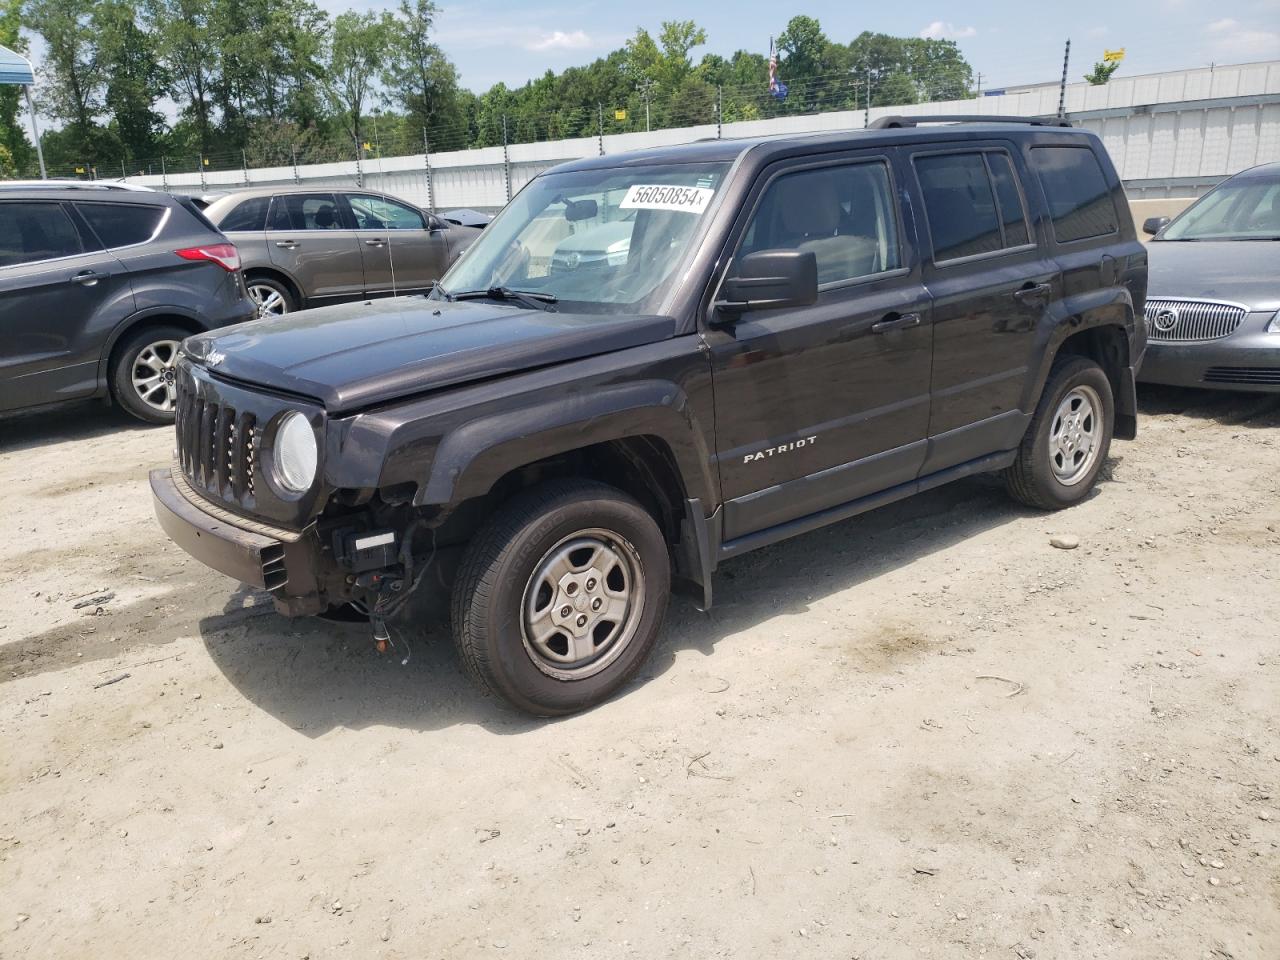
{"left": 184, "top": 296, "right": 676, "bottom": 413}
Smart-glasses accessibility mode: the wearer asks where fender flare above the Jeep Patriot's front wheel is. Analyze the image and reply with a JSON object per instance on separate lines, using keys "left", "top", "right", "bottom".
{"left": 413, "top": 380, "right": 717, "bottom": 507}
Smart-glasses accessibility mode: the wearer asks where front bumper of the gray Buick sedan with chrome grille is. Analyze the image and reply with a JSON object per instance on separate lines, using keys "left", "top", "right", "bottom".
{"left": 1138, "top": 330, "right": 1280, "bottom": 393}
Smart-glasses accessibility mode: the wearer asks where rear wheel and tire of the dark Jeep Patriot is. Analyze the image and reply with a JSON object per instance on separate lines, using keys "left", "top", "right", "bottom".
{"left": 1005, "top": 356, "right": 1115, "bottom": 509}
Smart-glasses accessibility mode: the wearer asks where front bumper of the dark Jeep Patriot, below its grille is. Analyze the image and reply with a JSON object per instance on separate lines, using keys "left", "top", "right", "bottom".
{"left": 151, "top": 468, "right": 325, "bottom": 616}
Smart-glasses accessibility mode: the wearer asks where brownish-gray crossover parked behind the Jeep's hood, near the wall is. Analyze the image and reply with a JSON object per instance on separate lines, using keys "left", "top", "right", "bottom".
{"left": 205, "top": 187, "right": 480, "bottom": 316}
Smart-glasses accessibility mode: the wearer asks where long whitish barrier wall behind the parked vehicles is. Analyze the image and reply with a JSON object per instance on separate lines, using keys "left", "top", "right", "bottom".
{"left": 129, "top": 60, "right": 1280, "bottom": 210}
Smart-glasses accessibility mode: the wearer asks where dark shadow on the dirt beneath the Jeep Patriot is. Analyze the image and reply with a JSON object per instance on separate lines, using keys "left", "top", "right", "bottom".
{"left": 198, "top": 471, "right": 1049, "bottom": 737}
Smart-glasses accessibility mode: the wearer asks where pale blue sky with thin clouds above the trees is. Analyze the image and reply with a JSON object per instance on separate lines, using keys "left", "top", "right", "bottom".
{"left": 320, "top": 0, "right": 1280, "bottom": 91}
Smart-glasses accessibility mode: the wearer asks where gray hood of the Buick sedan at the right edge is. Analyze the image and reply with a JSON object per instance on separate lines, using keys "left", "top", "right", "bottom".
{"left": 1147, "top": 241, "right": 1280, "bottom": 311}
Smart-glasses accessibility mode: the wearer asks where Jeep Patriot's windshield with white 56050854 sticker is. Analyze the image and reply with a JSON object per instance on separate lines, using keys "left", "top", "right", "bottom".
{"left": 433, "top": 163, "right": 728, "bottom": 314}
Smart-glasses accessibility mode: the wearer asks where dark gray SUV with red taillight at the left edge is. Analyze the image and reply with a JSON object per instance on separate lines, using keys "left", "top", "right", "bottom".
{"left": 0, "top": 180, "right": 253, "bottom": 424}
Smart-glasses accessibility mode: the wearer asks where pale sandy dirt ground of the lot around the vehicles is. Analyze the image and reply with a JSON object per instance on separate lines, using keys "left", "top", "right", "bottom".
{"left": 0, "top": 390, "right": 1280, "bottom": 960}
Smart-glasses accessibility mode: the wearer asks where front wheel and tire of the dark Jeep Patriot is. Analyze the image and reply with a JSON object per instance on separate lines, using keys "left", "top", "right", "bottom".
{"left": 452, "top": 480, "right": 671, "bottom": 717}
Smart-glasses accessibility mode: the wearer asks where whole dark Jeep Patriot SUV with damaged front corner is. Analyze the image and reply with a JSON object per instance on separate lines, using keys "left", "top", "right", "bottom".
{"left": 151, "top": 118, "right": 1147, "bottom": 714}
